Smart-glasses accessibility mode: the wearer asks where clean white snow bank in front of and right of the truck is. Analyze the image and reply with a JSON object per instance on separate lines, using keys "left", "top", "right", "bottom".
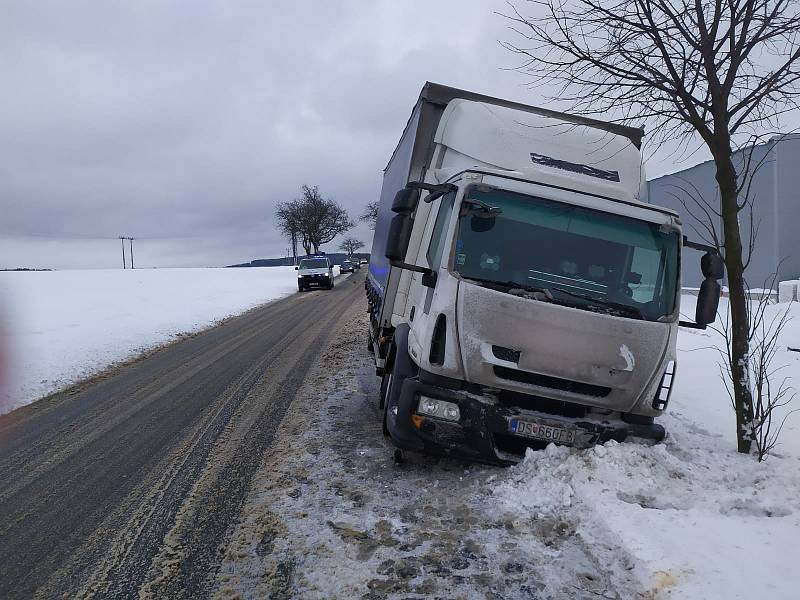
{"left": 495, "top": 297, "right": 800, "bottom": 600}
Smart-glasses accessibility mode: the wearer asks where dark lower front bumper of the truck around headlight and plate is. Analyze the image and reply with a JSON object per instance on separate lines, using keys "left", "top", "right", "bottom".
{"left": 386, "top": 377, "right": 665, "bottom": 464}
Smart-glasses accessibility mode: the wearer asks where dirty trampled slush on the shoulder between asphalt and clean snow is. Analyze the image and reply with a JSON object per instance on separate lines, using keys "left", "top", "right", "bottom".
{"left": 216, "top": 306, "right": 638, "bottom": 599}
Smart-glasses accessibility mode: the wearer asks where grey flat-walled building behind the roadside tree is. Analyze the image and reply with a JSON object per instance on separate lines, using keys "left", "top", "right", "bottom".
{"left": 647, "top": 134, "right": 800, "bottom": 288}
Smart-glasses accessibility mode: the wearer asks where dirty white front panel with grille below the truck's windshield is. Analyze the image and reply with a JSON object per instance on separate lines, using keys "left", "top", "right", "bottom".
{"left": 456, "top": 280, "right": 670, "bottom": 412}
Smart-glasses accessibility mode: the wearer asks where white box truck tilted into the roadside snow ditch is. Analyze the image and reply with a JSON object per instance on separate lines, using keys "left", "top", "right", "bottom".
{"left": 365, "top": 83, "right": 723, "bottom": 464}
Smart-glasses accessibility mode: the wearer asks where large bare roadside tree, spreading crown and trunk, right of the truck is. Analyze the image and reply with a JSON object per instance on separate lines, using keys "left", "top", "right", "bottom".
{"left": 504, "top": 0, "right": 800, "bottom": 452}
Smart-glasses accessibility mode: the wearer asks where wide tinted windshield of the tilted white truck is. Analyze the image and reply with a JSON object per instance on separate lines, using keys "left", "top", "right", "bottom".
{"left": 453, "top": 189, "right": 679, "bottom": 320}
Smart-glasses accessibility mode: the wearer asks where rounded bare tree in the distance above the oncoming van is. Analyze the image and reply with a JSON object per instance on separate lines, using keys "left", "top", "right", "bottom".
{"left": 275, "top": 185, "right": 353, "bottom": 255}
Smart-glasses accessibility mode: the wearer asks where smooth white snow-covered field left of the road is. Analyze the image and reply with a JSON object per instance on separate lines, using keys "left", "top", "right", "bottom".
{"left": 0, "top": 267, "right": 338, "bottom": 414}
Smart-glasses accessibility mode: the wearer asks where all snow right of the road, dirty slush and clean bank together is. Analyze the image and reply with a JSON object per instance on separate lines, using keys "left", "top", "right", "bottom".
{"left": 216, "top": 298, "right": 800, "bottom": 600}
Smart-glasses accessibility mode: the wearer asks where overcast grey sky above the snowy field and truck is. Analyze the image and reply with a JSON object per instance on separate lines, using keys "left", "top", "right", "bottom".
{"left": 0, "top": 0, "right": 788, "bottom": 268}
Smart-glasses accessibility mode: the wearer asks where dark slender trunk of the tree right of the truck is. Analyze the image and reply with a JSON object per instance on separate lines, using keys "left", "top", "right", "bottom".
{"left": 714, "top": 140, "right": 753, "bottom": 453}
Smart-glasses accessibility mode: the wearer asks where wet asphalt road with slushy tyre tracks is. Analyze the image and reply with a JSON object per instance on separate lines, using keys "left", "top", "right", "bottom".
{"left": 0, "top": 272, "right": 364, "bottom": 598}
